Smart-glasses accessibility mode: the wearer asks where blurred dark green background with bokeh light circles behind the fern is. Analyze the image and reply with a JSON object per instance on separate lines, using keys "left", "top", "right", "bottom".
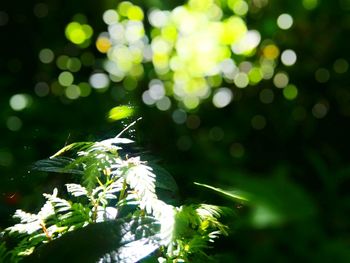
{"left": 0, "top": 0, "right": 350, "bottom": 262}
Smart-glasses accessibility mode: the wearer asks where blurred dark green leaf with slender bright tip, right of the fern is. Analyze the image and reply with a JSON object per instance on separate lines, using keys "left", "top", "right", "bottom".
{"left": 196, "top": 175, "right": 316, "bottom": 228}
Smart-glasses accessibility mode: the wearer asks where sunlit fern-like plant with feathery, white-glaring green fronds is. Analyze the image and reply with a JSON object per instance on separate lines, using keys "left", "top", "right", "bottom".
{"left": 0, "top": 136, "right": 227, "bottom": 263}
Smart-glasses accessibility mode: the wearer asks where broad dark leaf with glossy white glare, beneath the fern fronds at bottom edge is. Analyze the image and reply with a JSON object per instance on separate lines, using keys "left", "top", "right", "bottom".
{"left": 23, "top": 217, "right": 159, "bottom": 263}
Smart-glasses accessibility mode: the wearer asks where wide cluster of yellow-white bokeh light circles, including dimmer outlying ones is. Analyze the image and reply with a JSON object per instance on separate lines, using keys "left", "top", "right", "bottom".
{"left": 21, "top": 0, "right": 308, "bottom": 115}
